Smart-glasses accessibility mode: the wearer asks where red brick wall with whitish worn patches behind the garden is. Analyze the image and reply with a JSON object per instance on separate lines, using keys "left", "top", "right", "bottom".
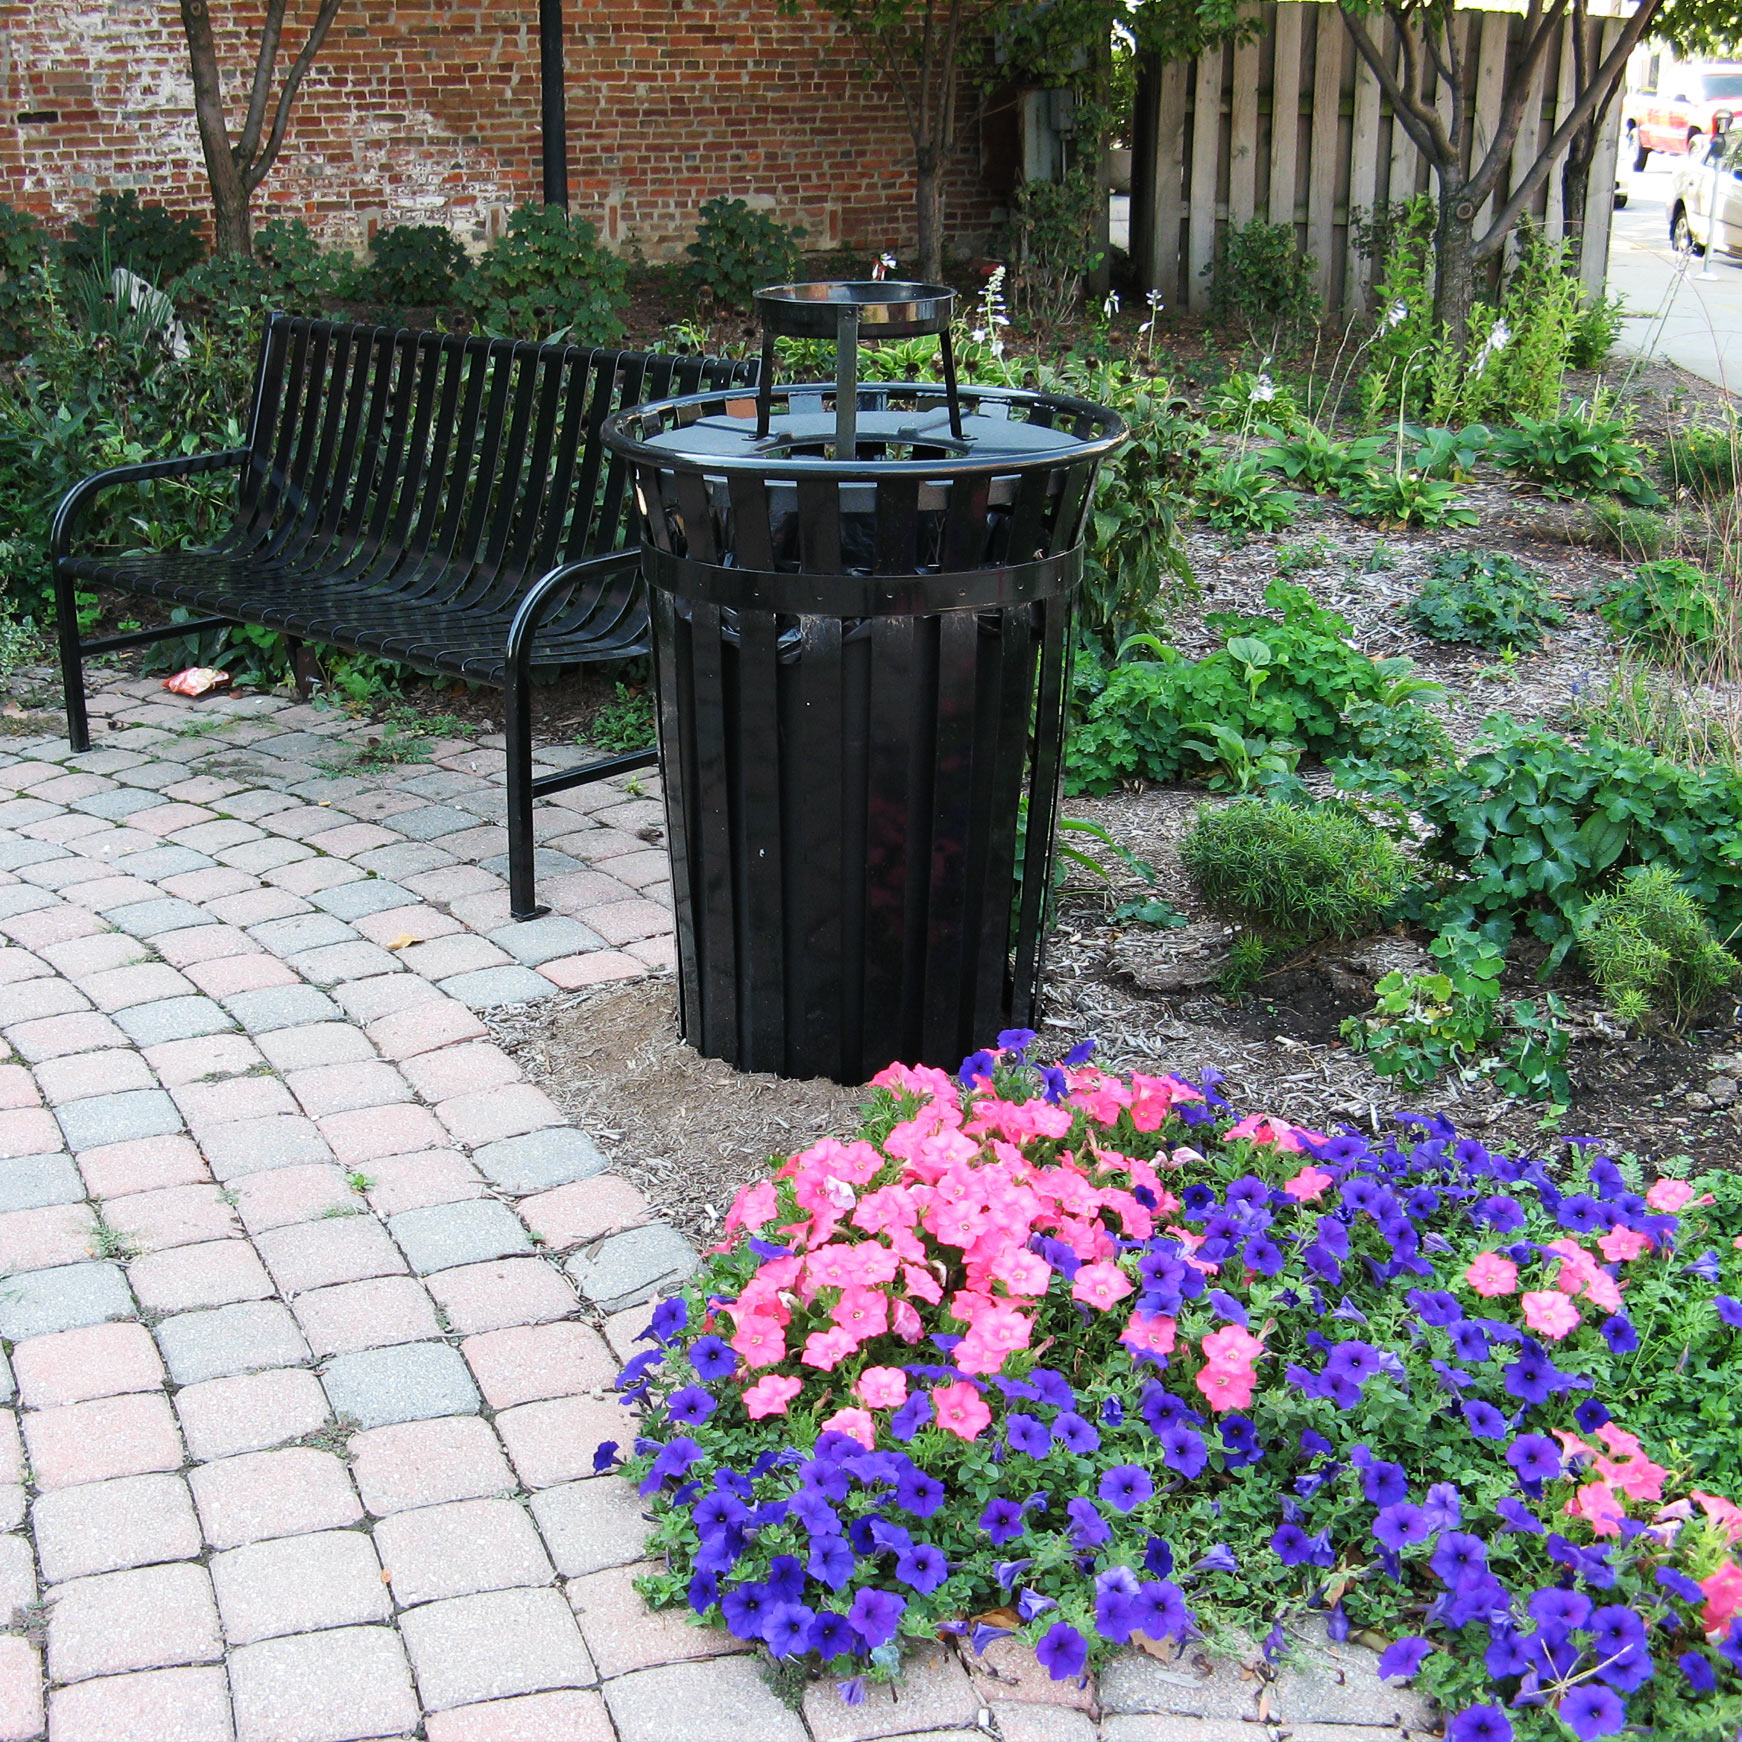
{"left": 0, "top": 0, "right": 991, "bottom": 260}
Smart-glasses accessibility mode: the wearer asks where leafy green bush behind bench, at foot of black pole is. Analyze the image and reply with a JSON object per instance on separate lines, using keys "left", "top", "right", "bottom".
{"left": 458, "top": 206, "right": 629, "bottom": 345}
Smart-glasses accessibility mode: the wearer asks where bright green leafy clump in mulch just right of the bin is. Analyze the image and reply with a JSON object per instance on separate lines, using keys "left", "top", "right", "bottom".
{"left": 1066, "top": 580, "right": 1415, "bottom": 793}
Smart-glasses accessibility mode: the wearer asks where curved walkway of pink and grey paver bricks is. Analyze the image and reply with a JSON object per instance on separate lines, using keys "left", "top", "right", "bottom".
{"left": 0, "top": 683, "right": 1427, "bottom": 1742}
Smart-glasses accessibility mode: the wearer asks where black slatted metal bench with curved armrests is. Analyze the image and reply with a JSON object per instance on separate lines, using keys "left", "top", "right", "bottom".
{"left": 51, "top": 315, "right": 756, "bottom": 920}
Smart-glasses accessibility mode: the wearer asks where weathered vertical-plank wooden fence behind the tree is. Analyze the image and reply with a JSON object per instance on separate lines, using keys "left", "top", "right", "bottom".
{"left": 1131, "top": 0, "right": 1622, "bottom": 312}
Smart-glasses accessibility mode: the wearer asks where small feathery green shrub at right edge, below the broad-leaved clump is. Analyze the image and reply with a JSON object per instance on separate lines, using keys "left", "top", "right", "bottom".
{"left": 1578, "top": 866, "right": 1742, "bottom": 1035}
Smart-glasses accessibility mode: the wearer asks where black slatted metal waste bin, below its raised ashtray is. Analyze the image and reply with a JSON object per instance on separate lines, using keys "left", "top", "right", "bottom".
{"left": 606, "top": 287, "right": 1124, "bottom": 1084}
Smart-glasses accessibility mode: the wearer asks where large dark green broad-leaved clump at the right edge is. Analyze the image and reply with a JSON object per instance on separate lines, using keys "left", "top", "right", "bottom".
{"left": 1345, "top": 714, "right": 1742, "bottom": 972}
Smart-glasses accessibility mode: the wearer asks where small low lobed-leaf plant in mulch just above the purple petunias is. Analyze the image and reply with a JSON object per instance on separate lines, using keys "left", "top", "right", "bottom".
{"left": 1343, "top": 930, "right": 1571, "bottom": 1104}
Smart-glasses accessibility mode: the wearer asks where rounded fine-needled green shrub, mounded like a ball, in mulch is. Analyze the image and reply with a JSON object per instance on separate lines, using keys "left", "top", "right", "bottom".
{"left": 1179, "top": 798, "right": 1409, "bottom": 944}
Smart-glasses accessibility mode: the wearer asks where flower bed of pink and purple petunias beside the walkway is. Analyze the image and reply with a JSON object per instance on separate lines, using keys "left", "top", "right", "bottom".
{"left": 599, "top": 1031, "right": 1742, "bottom": 1742}
